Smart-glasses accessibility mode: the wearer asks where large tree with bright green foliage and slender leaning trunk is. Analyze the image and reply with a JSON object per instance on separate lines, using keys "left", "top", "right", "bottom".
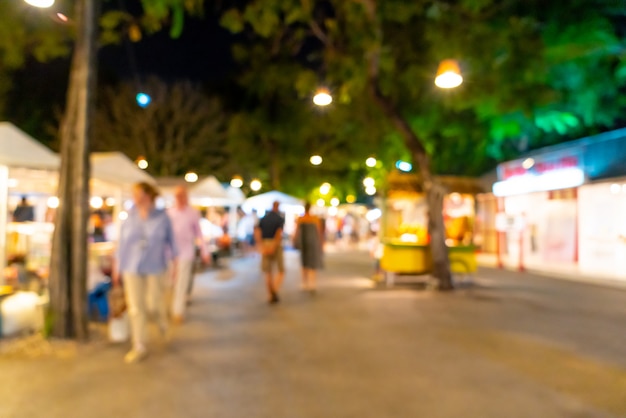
{"left": 224, "top": 0, "right": 623, "bottom": 289}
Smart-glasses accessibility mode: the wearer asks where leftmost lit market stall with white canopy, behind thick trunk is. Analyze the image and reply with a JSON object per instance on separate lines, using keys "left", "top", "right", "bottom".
{"left": 0, "top": 122, "right": 60, "bottom": 336}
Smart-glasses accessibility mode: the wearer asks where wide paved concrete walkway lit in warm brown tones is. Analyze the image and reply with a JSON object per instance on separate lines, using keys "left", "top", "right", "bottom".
{"left": 0, "top": 252, "right": 626, "bottom": 418}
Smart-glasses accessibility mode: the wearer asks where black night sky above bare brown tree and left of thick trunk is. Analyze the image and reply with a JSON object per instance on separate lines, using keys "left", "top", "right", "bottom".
{"left": 7, "top": 11, "right": 236, "bottom": 148}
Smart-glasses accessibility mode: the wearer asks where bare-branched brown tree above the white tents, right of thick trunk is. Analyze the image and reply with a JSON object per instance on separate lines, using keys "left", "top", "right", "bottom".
{"left": 93, "top": 77, "right": 230, "bottom": 176}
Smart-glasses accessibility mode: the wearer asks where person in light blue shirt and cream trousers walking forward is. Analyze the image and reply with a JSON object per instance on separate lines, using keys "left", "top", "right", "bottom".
{"left": 113, "top": 183, "right": 177, "bottom": 363}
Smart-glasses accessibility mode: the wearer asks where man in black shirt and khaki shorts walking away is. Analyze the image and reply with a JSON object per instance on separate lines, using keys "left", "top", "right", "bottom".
{"left": 254, "top": 202, "right": 285, "bottom": 304}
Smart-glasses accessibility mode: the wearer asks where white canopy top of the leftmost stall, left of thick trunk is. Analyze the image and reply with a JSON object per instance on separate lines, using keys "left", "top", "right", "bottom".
{"left": 0, "top": 122, "right": 60, "bottom": 170}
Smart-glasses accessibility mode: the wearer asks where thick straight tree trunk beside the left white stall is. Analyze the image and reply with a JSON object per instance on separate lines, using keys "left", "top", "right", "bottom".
{"left": 50, "top": 0, "right": 98, "bottom": 340}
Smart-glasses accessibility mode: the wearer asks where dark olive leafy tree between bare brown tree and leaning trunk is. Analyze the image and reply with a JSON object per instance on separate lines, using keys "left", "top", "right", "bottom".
{"left": 222, "top": 5, "right": 394, "bottom": 197}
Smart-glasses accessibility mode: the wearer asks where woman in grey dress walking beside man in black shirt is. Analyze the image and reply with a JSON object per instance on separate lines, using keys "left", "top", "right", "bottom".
{"left": 294, "top": 202, "right": 324, "bottom": 292}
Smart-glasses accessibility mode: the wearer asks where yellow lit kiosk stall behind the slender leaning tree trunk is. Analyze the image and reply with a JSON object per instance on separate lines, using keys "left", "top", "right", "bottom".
{"left": 380, "top": 172, "right": 480, "bottom": 282}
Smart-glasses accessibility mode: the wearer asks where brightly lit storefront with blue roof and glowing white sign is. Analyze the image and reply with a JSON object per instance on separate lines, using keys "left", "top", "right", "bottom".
{"left": 478, "top": 129, "right": 626, "bottom": 280}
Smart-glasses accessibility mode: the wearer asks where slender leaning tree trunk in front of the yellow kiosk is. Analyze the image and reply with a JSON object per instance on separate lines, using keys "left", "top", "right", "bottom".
{"left": 370, "top": 82, "right": 454, "bottom": 290}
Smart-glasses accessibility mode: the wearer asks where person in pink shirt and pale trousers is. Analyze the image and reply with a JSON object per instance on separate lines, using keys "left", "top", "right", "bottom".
{"left": 168, "top": 186, "right": 209, "bottom": 325}
